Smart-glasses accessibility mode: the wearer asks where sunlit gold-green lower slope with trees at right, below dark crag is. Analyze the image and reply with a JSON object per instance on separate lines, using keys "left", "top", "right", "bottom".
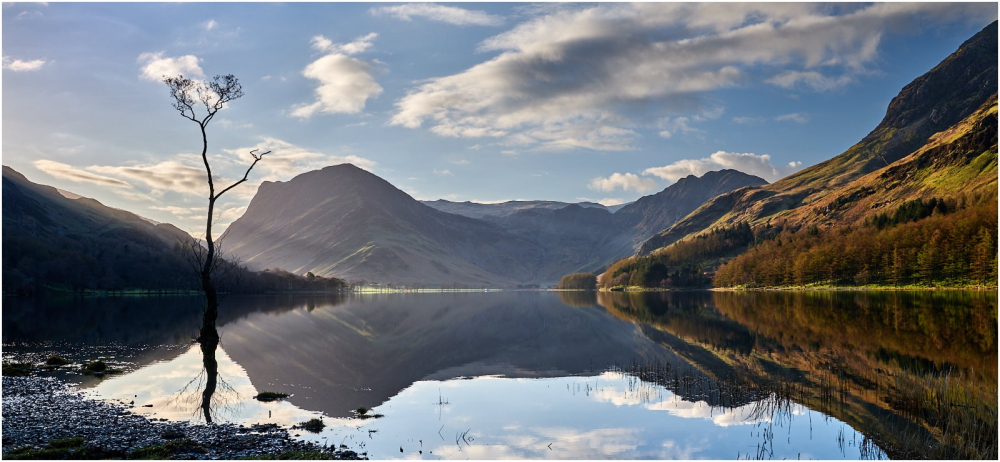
{"left": 601, "top": 95, "right": 997, "bottom": 287}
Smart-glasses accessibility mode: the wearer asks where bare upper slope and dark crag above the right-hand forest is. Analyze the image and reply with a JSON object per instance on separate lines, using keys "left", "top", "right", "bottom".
{"left": 639, "top": 21, "right": 997, "bottom": 254}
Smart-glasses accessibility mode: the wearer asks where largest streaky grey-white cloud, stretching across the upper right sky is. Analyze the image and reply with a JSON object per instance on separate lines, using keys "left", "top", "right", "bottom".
{"left": 391, "top": 3, "right": 996, "bottom": 150}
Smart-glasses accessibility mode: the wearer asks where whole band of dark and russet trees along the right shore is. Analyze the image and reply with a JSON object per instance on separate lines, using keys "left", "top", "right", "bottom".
{"left": 599, "top": 190, "right": 997, "bottom": 289}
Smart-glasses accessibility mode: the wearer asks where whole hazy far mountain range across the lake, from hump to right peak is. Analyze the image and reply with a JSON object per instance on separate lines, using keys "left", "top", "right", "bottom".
{"left": 223, "top": 164, "right": 764, "bottom": 287}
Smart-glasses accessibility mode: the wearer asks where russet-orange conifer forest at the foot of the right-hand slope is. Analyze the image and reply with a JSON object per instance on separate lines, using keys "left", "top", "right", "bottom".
{"left": 713, "top": 194, "right": 997, "bottom": 287}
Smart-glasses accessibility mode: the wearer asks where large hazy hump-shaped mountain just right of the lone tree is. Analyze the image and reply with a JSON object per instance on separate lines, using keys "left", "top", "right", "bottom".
{"left": 223, "top": 164, "right": 542, "bottom": 287}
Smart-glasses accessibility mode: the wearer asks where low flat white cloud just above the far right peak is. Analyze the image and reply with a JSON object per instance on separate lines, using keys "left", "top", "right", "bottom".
{"left": 643, "top": 151, "right": 802, "bottom": 182}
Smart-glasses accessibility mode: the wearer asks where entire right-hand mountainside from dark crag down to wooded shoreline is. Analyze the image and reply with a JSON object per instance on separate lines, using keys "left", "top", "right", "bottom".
{"left": 601, "top": 22, "right": 997, "bottom": 287}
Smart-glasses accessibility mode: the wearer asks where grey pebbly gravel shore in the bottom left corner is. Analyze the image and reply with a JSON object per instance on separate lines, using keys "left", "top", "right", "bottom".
{"left": 3, "top": 377, "right": 361, "bottom": 459}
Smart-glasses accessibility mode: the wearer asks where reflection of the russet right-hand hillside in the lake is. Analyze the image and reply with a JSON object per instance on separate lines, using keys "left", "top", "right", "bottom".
{"left": 598, "top": 291, "right": 997, "bottom": 458}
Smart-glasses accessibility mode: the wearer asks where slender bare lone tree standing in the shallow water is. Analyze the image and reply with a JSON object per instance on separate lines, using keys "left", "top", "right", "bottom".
{"left": 163, "top": 74, "right": 271, "bottom": 349}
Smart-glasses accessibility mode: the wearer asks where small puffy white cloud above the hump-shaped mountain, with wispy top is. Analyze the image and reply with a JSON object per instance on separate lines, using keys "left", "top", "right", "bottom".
{"left": 291, "top": 33, "right": 382, "bottom": 119}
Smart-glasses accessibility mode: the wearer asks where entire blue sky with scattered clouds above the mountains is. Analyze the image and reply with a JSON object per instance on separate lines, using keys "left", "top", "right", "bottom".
{"left": 0, "top": 2, "right": 997, "bottom": 235}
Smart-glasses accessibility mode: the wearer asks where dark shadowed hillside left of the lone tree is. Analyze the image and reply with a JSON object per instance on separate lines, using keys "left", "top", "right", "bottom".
{"left": 3, "top": 166, "right": 197, "bottom": 293}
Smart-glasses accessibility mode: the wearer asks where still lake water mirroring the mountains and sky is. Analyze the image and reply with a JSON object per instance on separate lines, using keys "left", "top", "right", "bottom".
{"left": 3, "top": 291, "right": 997, "bottom": 459}
